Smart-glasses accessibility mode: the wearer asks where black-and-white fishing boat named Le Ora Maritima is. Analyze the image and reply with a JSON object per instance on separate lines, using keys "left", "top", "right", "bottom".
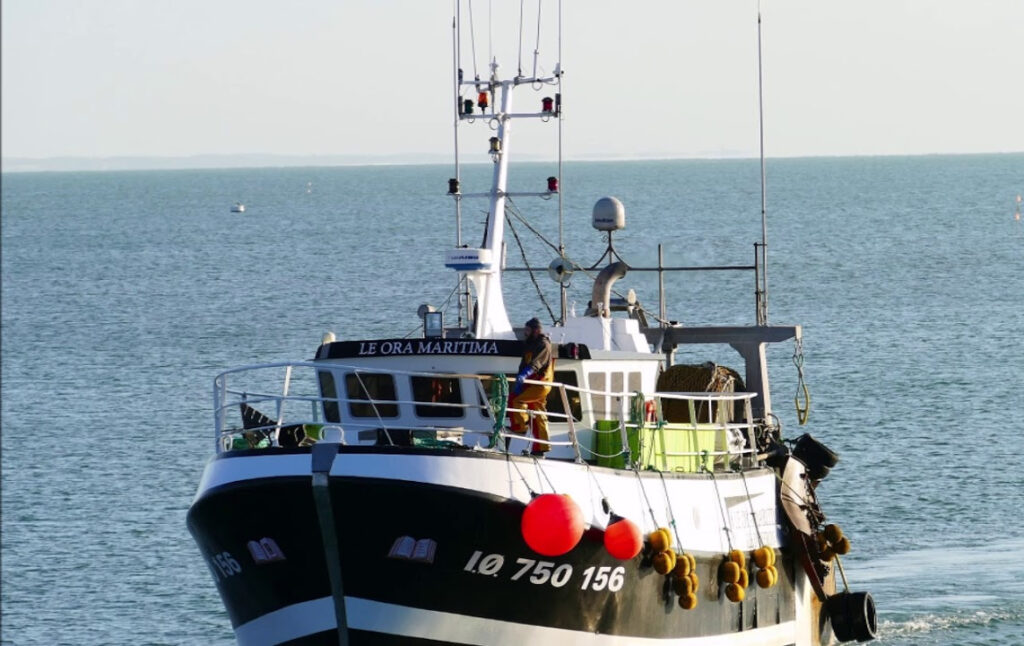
{"left": 187, "top": 3, "right": 876, "bottom": 646}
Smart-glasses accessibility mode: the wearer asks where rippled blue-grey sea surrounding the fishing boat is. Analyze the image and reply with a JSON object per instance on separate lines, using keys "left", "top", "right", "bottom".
{"left": 0, "top": 155, "right": 1024, "bottom": 646}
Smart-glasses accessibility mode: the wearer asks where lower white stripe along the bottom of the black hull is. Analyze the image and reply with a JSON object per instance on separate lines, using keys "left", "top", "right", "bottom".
{"left": 234, "top": 597, "right": 797, "bottom": 646}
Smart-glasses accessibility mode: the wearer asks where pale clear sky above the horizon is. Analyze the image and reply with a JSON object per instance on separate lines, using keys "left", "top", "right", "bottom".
{"left": 0, "top": 0, "right": 1024, "bottom": 159}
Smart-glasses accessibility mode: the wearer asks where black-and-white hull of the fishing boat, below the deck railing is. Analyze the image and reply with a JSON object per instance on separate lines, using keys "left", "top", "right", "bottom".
{"left": 188, "top": 447, "right": 820, "bottom": 646}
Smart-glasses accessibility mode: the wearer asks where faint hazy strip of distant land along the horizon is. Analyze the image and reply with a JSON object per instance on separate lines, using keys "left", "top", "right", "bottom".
{"left": 0, "top": 150, "right": 1024, "bottom": 174}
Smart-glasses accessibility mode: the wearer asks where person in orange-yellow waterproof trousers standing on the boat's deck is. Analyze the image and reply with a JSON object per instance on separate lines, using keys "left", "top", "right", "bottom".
{"left": 509, "top": 317, "right": 555, "bottom": 457}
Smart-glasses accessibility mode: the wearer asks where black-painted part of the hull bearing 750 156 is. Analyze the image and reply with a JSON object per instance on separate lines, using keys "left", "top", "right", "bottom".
{"left": 188, "top": 450, "right": 797, "bottom": 645}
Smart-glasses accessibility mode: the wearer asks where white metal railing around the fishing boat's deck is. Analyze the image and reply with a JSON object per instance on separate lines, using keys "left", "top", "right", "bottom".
{"left": 213, "top": 362, "right": 757, "bottom": 472}
